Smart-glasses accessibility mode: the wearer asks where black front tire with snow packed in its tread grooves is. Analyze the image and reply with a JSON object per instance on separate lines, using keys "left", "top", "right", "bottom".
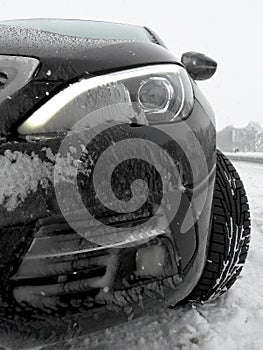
{"left": 187, "top": 151, "right": 250, "bottom": 302}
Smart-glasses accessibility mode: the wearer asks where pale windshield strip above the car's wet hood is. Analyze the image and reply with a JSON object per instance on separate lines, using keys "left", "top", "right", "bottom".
{"left": 0, "top": 19, "right": 152, "bottom": 42}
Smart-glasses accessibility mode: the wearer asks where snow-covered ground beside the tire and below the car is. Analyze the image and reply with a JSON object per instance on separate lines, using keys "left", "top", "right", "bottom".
{"left": 59, "top": 162, "right": 263, "bottom": 350}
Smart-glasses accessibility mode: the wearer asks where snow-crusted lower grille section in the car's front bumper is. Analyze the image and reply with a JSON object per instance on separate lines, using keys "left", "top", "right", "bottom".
{"left": 11, "top": 211, "right": 184, "bottom": 309}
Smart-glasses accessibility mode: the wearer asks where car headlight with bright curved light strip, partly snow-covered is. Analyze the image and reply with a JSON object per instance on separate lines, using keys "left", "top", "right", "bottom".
{"left": 18, "top": 64, "right": 194, "bottom": 134}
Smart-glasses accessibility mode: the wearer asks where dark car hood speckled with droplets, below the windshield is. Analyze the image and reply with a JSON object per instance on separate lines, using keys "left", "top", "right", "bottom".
{"left": 0, "top": 24, "right": 180, "bottom": 81}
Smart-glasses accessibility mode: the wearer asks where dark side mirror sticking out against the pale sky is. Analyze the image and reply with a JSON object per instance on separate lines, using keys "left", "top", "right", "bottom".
{"left": 181, "top": 52, "right": 217, "bottom": 80}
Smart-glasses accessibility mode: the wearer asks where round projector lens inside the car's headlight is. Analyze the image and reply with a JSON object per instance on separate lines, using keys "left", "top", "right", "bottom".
{"left": 138, "top": 77, "right": 173, "bottom": 113}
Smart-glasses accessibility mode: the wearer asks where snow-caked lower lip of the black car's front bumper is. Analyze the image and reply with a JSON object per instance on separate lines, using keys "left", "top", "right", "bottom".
{"left": 0, "top": 169, "right": 217, "bottom": 349}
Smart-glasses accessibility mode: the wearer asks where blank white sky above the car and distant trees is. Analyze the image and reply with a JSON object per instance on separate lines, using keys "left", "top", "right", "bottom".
{"left": 0, "top": 0, "right": 263, "bottom": 129}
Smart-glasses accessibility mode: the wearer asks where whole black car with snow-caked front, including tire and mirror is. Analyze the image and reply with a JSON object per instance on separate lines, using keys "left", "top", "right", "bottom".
{"left": 0, "top": 19, "right": 250, "bottom": 349}
